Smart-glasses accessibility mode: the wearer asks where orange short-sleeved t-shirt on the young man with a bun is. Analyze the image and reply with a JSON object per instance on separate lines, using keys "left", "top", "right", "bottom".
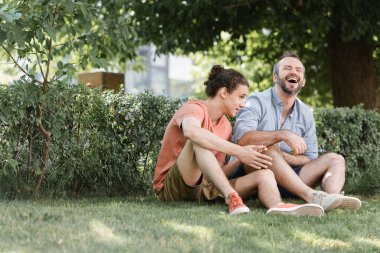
{"left": 153, "top": 100, "right": 232, "bottom": 192}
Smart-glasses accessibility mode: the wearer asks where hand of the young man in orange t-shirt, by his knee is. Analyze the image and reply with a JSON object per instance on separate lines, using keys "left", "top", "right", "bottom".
{"left": 237, "top": 145, "right": 272, "bottom": 169}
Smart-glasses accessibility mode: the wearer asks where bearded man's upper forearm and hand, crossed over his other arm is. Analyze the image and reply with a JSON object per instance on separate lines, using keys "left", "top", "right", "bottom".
{"left": 238, "top": 130, "right": 307, "bottom": 155}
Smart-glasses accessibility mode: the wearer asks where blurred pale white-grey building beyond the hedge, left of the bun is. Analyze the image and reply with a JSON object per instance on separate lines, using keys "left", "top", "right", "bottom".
{"left": 125, "top": 46, "right": 194, "bottom": 98}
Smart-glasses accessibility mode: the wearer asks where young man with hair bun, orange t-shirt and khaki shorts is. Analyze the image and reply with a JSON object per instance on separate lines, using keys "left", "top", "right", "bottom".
{"left": 153, "top": 65, "right": 324, "bottom": 216}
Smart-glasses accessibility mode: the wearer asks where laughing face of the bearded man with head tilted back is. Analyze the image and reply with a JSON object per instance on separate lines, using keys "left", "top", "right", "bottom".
{"left": 273, "top": 57, "right": 305, "bottom": 95}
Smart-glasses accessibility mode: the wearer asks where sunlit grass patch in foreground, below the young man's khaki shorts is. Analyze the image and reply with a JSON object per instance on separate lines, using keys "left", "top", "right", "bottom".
{"left": 164, "top": 222, "right": 214, "bottom": 243}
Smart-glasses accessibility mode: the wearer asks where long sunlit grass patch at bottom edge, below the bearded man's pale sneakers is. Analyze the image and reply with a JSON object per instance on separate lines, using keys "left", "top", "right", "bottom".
{"left": 294, "top": 230, "right": 352, "bottom": 249}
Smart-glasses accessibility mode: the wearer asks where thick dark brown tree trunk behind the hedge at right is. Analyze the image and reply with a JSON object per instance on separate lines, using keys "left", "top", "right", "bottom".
{"left": 329, "top": 32, "right": 380, "bottom": 111}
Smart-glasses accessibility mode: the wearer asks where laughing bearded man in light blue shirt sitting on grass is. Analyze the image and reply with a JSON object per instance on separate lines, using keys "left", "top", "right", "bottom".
{"left": 233, "top": 52, "right": 361, "bottom": 211}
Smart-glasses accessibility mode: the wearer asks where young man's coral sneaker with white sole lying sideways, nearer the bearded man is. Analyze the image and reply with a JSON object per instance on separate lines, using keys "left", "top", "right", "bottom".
{"left": 267, "top": 203, "right": 325, "bottom": 217}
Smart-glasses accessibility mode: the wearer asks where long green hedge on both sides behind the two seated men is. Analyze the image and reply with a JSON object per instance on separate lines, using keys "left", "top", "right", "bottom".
{"left": 0, "top": 81, "right": 380, "bottom": 197}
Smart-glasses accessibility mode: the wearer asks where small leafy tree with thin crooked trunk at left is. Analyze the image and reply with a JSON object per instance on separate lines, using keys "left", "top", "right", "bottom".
{"left": 0, "top": 0, "right": 139, "bottom": 192}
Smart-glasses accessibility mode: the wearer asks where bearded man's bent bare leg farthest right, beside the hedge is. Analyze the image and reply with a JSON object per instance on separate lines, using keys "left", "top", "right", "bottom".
{"left": 299, "top": 153, "right": 346, "bottom": 194}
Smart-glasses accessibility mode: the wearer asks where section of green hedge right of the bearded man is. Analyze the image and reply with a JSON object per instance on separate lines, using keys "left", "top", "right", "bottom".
{"left": 315, "top": 107, "right": 380, "bottom": 194}
